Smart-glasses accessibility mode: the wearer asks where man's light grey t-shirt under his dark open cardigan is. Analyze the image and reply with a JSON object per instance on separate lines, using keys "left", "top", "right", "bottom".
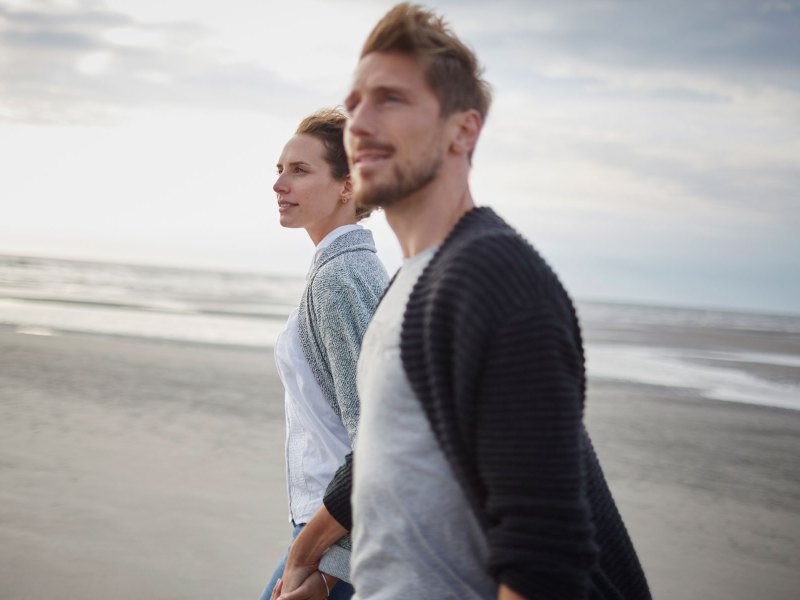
{"left": 351, "top": 247, "right": 497, "bottom": 600}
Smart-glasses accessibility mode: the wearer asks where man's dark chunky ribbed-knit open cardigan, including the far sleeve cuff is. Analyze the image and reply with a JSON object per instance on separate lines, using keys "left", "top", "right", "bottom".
{"left": 325, "top": 208, "right": 650, "bottom": 600}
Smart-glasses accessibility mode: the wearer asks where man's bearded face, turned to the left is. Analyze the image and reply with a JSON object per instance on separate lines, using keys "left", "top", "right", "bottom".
{"left": 344, "top": 52, "right": 446, "bottom": 207}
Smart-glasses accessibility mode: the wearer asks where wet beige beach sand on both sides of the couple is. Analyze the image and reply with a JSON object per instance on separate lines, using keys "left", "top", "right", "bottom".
{"left": 0, "top": 328, "right": 800, "bottom": 600}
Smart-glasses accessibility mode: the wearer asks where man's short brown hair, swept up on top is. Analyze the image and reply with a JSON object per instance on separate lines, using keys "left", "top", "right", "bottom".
{"left": 361, "top": 2, "right": 492, "bottom": 120}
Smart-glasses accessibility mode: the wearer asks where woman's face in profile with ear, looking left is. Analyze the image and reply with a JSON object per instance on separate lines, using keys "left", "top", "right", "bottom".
{"left": 272, "top": 134, "right": 355, "bottom": 244}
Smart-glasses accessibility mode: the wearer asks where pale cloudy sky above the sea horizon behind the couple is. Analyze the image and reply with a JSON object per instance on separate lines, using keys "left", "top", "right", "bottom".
{"left": 0, "top": 0, "right": 800, "bottom": 314}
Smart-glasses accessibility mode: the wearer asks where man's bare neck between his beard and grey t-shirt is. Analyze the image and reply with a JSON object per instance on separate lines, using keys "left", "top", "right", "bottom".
{"left": 386, "top": 166, "right": 475, "bottom": 258}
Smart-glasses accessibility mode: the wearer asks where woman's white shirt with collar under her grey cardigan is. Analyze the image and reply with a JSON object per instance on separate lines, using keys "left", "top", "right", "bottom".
{"left": 275, "top": 225, "right": 361, "bottom": 523}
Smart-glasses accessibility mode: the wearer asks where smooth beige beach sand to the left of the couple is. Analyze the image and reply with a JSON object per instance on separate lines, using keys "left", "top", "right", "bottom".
{"left": 0, "top": 328, "right": 290, "bottom": 600}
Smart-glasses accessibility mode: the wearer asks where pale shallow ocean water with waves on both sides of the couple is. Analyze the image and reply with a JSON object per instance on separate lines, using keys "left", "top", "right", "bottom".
{"left": 0, "top": 255, "right": 800, "bottom": 410}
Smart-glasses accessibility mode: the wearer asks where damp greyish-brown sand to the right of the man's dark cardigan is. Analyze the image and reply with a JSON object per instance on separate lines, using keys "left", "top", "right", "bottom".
{"left": 587, "top": 384, "right": 800, "bottom": 600}
